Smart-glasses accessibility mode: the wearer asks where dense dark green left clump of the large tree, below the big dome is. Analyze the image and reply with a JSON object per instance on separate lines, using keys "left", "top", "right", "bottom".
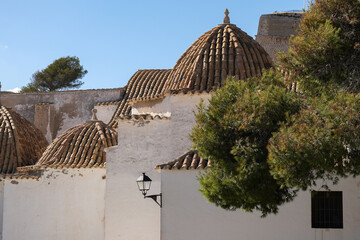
{"left": 191, "top": 72, "right": 301, "bottom": 215}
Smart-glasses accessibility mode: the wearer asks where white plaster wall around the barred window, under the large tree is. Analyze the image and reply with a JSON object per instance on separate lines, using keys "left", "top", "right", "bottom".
{"left": 161, "top": 170, "right": 360, "bottom": 240}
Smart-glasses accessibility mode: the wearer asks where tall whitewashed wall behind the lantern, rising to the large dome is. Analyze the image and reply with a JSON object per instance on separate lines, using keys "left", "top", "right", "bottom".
{"left": 105, "top": 94, "right": 209, "bottom": 240}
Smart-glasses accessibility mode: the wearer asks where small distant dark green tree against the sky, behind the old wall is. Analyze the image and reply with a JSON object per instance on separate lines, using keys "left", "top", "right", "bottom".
{"left": 21, "top": 56, "right": 87, "bottom": 92}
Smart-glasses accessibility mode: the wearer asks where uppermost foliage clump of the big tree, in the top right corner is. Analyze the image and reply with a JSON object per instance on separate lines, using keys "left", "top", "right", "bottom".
{"left": 279, "top": 0, "right": 360, "bottom": 94}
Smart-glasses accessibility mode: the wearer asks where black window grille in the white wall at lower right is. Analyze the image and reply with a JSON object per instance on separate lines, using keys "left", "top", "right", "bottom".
{"left": 311, "top": 191, "right": 343, "bottom": 228}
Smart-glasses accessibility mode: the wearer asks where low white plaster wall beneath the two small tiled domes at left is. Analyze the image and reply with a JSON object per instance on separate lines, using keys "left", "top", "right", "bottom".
{"left": 3, "top": 168, "right": 105, "bottom": 240}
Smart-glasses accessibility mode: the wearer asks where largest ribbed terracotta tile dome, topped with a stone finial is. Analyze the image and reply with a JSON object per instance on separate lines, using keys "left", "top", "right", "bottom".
{"left": 164, "top": 10, "right": 272, "bottom": 91}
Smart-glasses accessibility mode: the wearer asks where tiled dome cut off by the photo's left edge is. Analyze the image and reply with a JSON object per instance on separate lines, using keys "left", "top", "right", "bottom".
{"left": 0, "top": 105, "right": 48, "bottom": 174}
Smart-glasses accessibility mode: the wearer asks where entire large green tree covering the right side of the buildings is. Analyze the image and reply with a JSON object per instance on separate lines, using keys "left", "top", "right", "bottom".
{"left": 191, "top": 0, "right": 360, "bottom": 216}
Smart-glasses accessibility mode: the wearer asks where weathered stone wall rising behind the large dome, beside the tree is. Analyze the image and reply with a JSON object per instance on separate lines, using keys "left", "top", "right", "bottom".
{"left": 255, "top": 12, "right": 303, "bottom": 60}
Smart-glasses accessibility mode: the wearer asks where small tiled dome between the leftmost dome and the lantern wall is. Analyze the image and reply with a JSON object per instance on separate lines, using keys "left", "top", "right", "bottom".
{"left": 35, "top": 109, "right": 117, "bottom": 168}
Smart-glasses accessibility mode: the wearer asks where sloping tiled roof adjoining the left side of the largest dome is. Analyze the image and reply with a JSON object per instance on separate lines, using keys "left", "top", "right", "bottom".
{"left": 109, "top": 69, "right": 171, "bottom": 128}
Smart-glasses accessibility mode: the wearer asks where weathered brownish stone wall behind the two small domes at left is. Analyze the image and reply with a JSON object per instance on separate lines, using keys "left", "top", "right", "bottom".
{"left": 0, "top": 88, "right": 124, "bottom": 142}
